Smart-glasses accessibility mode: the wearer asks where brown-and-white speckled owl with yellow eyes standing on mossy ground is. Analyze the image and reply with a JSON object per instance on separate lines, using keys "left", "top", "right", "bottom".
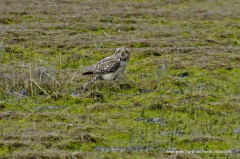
{"left": 82, "top": 47, "right": 130, "bottom": 92}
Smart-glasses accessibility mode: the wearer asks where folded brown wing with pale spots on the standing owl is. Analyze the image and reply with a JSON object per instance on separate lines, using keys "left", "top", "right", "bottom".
{"left": 82, "top": 57, "right": 120, "bottom": 75}
